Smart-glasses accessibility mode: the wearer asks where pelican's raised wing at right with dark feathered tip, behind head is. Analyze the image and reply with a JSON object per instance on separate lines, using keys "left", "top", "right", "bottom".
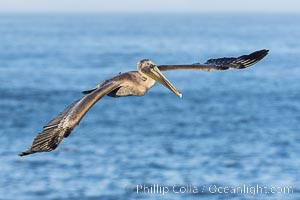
{"left": 158, "top": 49, "right": 269, "bottom": 71}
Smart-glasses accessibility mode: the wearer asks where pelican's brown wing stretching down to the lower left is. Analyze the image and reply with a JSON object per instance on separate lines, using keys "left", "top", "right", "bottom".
{"left": 19, "top": 80, "right": 120, "bottom": 156}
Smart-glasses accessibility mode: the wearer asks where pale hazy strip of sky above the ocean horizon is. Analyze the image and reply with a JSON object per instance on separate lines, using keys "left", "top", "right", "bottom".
{"left": 0, "top": 0, "right": 300, "bottom": 13}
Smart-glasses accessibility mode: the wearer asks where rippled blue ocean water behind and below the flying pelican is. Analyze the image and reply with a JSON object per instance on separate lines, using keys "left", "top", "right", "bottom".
{"left": 0, "top": 14, "right": 300, "bottom": 200}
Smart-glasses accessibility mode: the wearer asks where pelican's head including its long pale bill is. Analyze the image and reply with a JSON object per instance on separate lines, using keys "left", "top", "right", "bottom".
{"left": 137, "top": 59, "right": 182, "bottom": 98}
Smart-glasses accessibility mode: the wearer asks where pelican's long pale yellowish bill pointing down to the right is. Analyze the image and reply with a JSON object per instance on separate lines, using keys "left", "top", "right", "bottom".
{"left": 144, "top": 66, "right": 182, "bottom": 98}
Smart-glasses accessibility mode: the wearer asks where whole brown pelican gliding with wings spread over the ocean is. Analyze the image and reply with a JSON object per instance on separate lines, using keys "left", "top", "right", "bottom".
{"left": 19, "top": 49, "right": 268, "bottom": 156}
